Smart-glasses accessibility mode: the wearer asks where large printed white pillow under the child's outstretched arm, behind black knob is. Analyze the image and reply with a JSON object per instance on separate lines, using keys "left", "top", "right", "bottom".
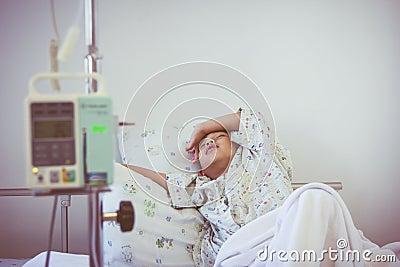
{"left": 103, "top": 163, "right": 203, "bottom": 267}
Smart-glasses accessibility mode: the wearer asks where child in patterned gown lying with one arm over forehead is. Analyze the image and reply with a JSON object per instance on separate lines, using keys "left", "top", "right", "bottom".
{"left": 123, "top": 109, "right": 292, "bottom": 266}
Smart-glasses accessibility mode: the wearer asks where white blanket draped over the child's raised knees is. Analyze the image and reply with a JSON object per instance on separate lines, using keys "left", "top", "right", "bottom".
{"left": 215, "top": 183, "right": 400, "bottom": 267}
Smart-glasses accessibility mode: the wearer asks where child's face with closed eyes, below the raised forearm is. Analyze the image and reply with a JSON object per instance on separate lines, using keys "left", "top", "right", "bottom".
{"left": 199, "top": 131, "right": 232, "bottom": 176}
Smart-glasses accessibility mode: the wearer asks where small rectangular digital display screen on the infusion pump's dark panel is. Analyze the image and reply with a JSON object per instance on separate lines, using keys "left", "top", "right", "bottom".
{"left": 33, "top": 120, "right": 73, "bottom": 139}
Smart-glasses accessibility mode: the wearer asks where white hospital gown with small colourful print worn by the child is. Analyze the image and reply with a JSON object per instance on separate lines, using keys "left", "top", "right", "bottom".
{"left": 167, "top": 109, "right": 292, "bottom": 266}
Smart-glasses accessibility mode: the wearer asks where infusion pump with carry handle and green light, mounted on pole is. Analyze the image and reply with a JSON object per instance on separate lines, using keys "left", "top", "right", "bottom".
{"left": 26, "top": 73, "right": 114, "bottom": 189}
